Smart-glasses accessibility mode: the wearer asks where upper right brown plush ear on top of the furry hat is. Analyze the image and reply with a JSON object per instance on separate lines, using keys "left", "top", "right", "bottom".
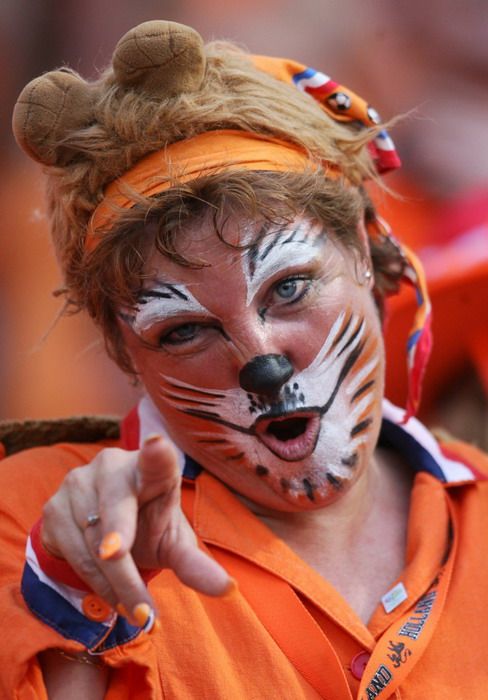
{"left": 112, "top": 20, "right": 205, "bottom": 97}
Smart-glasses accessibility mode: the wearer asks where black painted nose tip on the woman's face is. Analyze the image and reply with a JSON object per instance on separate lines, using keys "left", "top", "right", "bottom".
{"left": 239, "top": 355, "right": 293, "bottom": 396}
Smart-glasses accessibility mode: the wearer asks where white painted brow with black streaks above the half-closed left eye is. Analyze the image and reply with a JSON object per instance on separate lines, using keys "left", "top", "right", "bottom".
{"left": 130, "top": 282, "right": 210, "bottom": 333}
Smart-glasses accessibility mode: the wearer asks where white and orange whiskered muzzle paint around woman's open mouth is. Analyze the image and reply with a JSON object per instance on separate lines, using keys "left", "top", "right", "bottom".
{"left": 160, "top": 312, "right": 380, "bottom": 503}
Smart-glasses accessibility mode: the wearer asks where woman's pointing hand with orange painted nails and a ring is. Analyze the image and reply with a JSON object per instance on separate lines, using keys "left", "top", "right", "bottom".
{"left": 42, "top": 436, "right": 232, "bottom": 624}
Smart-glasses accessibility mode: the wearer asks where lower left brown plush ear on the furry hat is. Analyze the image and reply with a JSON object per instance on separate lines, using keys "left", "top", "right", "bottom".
{"left": 12, "top": 70, "right": 93, "bottom": 165}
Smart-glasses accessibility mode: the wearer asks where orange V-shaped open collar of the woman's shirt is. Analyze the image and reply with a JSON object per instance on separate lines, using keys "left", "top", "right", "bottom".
{"left": 187, "top": 462, "right": 449, "bottom": 648}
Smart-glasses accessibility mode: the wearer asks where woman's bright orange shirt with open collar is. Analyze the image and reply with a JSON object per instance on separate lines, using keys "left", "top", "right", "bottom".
{"left": 0, "top": 430, "right": 488, "bottom": 700}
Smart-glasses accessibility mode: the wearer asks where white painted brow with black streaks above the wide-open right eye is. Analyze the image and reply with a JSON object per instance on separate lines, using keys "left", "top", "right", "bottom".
{"left": 243, "top": 222, "right": 326, "bottom": 306}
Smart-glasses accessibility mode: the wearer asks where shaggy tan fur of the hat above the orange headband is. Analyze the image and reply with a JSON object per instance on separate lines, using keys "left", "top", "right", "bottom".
{"left": 47, "top": 42, "right": 375, "bottom": 300}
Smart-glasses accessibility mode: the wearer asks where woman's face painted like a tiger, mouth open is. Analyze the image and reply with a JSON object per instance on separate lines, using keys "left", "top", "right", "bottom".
{"left": 120, "top": 211, "right": 383, "bottom": 510}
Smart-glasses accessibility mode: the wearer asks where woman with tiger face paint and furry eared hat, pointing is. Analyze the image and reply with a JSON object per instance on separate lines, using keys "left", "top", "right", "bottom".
{"left": 2, "top": 22, "right": 487, "bottom": 699}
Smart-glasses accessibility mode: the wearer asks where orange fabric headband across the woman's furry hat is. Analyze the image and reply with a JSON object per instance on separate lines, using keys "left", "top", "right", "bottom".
{"left": 85, "top": 129, "right": 338, "bottom": 251}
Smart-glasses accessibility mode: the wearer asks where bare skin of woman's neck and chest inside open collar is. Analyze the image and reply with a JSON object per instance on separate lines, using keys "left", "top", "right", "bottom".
{"left": 244, "top": 450, "right": 411, "bottom": 622}
